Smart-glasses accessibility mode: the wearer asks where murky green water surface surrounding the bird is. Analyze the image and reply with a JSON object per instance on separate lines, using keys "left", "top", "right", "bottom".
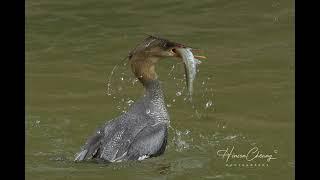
{"left": 25, "top": 0, "right": 295, "bottom": 180}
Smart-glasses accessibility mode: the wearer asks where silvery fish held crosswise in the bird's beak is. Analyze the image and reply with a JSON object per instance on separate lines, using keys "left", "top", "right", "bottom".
{"left": 176, "top": 48, "right": 204, "bottom": 101}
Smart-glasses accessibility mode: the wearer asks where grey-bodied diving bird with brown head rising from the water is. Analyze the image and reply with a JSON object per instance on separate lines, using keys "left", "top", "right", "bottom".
{"left": 75, "top": 35, "right": 204, "bottom": 162}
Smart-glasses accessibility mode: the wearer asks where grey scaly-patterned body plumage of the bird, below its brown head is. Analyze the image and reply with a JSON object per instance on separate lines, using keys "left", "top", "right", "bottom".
{"left": 75, "top": 80, "right": 169, "bottom": 162}
